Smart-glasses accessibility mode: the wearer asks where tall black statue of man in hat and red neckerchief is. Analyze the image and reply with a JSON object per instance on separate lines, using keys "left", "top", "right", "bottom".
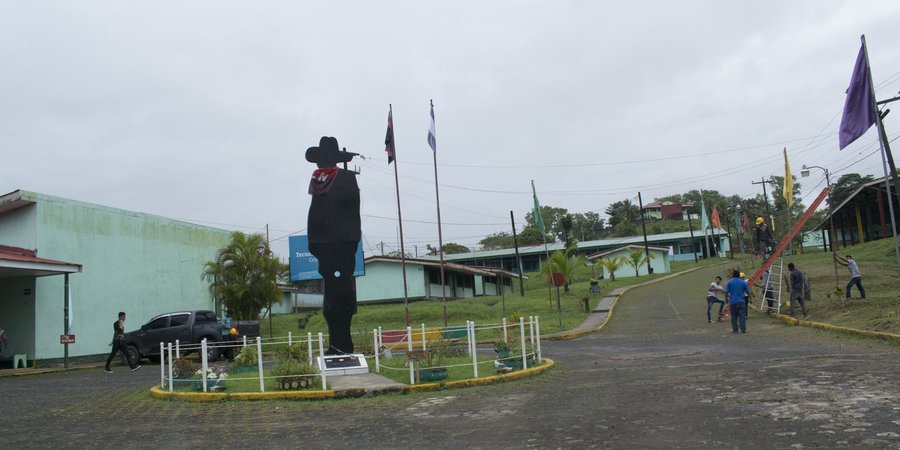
{"left": 306, "top": 136, "right": 361, "bottom": 355}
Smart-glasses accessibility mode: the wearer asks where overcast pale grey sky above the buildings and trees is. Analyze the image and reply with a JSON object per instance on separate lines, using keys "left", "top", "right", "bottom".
{"left": 0, "top": 0, "right": 900, "bottom": 256}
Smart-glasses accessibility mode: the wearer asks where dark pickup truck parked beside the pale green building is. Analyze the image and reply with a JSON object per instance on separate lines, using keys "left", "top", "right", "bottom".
{"left": 125, "top": 311, "right": 225, "bottom": 362}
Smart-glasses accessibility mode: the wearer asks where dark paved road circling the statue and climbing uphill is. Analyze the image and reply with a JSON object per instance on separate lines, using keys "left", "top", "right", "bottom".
{"left": 0, "top": 268, "right": 900, "bottom": 449}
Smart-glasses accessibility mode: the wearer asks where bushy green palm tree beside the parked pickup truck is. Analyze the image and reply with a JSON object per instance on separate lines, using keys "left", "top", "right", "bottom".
{"left": 202, "top": 231, "right": 290, "bottom": 320}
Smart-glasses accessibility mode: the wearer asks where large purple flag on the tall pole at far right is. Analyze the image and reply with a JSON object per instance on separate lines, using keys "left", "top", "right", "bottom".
{"left": 839, "top": 41, "right": 878, "bottom": 150}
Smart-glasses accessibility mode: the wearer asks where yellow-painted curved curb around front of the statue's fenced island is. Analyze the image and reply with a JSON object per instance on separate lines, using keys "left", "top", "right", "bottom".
{"left": 150, "top": 358, "right": 556, "bottom": 403}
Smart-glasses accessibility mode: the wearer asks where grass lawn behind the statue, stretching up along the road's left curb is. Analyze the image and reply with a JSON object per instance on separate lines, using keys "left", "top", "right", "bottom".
{"left": 260, "top": 255, "right": 721, "bottom": 340}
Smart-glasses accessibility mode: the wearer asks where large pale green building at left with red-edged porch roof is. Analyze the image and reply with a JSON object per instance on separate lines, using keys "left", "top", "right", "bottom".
{"left": 0, "top": 190, "right": 230, "bottom": 364}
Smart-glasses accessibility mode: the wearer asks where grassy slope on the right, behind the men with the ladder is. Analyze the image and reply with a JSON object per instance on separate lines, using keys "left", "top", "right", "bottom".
{"left": 745, "top": 239, "right": 900, "bottom": 334}
